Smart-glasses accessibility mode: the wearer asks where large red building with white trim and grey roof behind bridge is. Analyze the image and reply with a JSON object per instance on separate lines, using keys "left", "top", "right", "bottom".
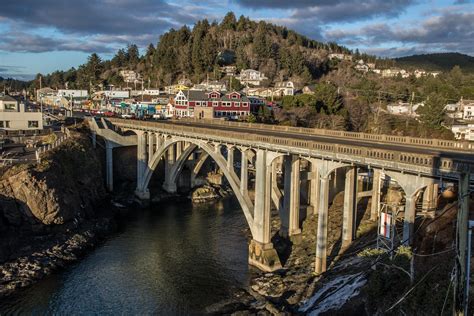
{"left": 168, "top": 90, "right": 250, "bottom": 117}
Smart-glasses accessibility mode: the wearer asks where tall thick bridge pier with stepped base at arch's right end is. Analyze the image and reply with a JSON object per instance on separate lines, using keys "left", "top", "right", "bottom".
{"left": 249, "top": 150, "right": 281, "bottom": 272}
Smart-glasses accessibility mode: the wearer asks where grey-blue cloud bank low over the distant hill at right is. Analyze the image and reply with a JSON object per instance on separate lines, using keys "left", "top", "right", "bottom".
{"left": 324, "top": 11, "right": 474, "bottom": 56}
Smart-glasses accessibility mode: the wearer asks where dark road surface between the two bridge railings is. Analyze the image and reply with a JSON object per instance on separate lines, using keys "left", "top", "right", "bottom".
{"left": 160, "top": 120, "right": 474, "bottom": 162}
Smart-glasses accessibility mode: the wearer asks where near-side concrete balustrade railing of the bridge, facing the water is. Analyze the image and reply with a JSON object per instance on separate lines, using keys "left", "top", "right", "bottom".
{"left": 109, "top": 118, "right": 473, "bottom": 171}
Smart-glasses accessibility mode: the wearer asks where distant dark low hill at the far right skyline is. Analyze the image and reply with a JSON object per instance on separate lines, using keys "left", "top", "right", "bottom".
{"left": 395, "top": 53, "right": 474, "bottom": 72}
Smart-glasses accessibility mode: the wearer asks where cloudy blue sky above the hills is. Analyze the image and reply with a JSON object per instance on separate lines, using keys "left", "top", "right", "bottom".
{"left": 0, "top": 0, "right": 474, "bottom": 79}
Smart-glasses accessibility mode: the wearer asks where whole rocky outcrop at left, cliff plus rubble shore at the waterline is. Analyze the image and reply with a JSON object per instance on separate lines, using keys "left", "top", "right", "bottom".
{"left": 0, "top": 126, "right": 109, "bottom": 294}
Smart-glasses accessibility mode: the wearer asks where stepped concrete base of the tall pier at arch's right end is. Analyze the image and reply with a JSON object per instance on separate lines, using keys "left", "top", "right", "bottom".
{"left": 249, "top": 239, "right": 281, "bottom": 272}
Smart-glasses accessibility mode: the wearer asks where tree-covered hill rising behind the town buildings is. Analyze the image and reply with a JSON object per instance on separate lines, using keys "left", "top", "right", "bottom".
{"left": 27, "top": 12, "right": 350, "bottom": 88}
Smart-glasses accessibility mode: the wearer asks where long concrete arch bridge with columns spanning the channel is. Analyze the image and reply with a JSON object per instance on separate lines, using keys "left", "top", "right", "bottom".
{"left": 88, "top": 118, "right": 474, "bottom": 273}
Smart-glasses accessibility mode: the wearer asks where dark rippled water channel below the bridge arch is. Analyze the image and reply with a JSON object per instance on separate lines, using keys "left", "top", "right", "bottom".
{"left": 0, "top": 198, "right": 249, "bottom": 315}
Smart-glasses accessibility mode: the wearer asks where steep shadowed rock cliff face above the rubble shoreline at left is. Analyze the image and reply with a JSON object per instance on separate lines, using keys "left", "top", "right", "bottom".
{"left": 0, "top": 128, "right": 105, "bottom": 261}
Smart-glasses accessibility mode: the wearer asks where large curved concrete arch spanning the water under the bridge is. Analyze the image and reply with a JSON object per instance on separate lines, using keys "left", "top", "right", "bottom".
{"left": 141, "top": 137, "right": 254, "bottom": 235}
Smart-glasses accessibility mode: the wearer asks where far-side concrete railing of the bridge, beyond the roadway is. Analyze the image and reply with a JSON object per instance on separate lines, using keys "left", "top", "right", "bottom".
{"left": 179, "top": 118, "right": 474, "bottom": 152}
